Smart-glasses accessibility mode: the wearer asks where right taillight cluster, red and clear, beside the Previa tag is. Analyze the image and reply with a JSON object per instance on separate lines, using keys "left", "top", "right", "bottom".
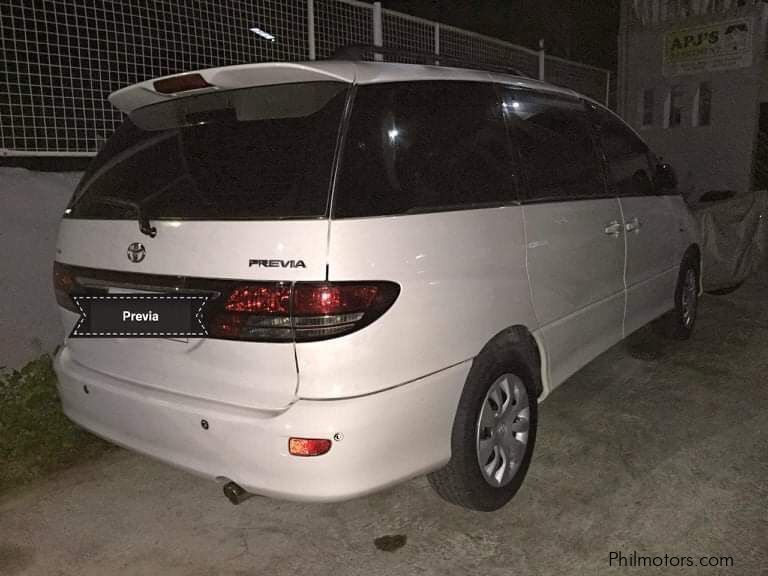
{"left": 207, "top": 282, "right": 400, "bottom": 342}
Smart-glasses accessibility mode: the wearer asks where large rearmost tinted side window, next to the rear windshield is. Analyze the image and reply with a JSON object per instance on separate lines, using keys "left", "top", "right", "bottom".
{"left": 334, "top": 81, "right": 517, "bottom": 218}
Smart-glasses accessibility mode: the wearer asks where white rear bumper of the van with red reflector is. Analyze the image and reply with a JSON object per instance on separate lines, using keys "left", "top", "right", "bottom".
{"left": 54, "top": 347, "right": 470, "bottom": 502}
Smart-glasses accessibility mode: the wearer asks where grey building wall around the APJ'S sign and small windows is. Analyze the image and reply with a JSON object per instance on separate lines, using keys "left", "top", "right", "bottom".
{"left": 619, "top": 4, "right": 768, "bottom": 200}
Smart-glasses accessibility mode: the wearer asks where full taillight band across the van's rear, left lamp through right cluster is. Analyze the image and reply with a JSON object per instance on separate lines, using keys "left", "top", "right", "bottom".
{"left": 53, "top": 262, "right": 400, "bottom": 342}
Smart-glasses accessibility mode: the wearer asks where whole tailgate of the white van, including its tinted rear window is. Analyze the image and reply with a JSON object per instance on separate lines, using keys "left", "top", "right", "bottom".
{"left": 56, "top": 75, "right": 349, "bottom": 409}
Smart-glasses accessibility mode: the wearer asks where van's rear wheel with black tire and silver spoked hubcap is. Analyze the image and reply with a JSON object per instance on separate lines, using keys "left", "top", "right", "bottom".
{"left": 427, "top": 336, "right": 538, "bottom": 512}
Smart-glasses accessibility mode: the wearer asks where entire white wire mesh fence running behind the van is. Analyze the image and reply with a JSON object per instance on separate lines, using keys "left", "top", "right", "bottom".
{"left": 0, "top": 0, "right": 610, "bottom": 156}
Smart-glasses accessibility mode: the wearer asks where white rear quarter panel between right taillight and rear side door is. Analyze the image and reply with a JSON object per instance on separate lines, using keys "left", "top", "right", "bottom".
{"left": 296, "top": 206, "right": 536, "bottom": 398}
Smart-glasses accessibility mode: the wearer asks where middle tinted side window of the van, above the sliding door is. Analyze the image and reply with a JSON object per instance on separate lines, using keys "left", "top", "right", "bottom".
{"left": 500, "top": 87, "right": 605, "bottom": 201}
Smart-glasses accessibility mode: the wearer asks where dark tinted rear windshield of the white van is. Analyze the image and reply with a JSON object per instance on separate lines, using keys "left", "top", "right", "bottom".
{"left": 68, "top": 82, "right": 348, "bottom": 220}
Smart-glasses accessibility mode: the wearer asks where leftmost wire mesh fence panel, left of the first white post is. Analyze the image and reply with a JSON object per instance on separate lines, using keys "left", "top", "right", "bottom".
{"left": 0, "top": 0, "right": 307, "bottom": 154}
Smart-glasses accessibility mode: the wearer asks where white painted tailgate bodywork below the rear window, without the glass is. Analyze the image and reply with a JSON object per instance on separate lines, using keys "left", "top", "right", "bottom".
{"left": 57, "top": 220, "right": 328, "bottom": 409}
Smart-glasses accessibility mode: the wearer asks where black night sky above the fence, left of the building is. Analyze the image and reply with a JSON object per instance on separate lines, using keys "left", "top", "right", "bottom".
{"left": 381, "top": 0, "right": 620, "bottom": 70}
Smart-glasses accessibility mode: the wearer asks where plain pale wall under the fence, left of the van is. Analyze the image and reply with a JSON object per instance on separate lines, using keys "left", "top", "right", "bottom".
{"left": 0, "top": 166, "right": 80, "bottom": 368}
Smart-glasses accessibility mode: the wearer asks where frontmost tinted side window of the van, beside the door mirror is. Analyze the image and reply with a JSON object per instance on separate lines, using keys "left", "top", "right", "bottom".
{"left": 592, "top": 107, "right": 655, "bottom": 196}
